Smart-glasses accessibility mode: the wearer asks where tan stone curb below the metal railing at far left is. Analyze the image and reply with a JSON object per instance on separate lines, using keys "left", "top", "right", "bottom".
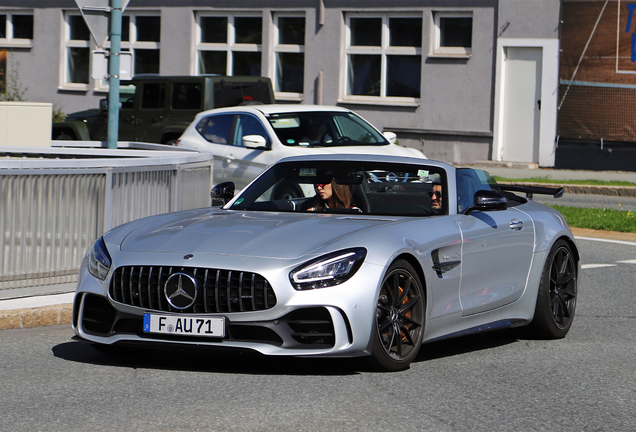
{"left": 0, "top": 304, "right": 73, "bottom": 330}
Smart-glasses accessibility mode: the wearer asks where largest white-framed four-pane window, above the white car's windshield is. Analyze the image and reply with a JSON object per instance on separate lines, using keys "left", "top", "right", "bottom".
{"left": 345, "top": 14, "right": 422, "bottom": 101}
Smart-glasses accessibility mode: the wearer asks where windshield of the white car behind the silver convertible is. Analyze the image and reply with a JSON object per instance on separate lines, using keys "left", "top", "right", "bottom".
{"left": 268, "top": 111, "right": 389, "bottom": 147}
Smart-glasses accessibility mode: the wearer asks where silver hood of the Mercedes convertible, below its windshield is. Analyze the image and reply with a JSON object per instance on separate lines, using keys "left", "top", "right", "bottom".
{"left": 121, "top": 209, "right": 394, "bottom": 259}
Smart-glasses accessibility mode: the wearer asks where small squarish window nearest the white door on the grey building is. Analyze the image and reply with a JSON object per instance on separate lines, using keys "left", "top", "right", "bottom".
{"left": 431, "top": 12, "right": 473, "bottom": 56}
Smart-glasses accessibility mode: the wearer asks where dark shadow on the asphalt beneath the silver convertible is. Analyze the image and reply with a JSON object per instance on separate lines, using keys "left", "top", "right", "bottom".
{"left": 52, "top": 331, "right": 517, "bottom": 376}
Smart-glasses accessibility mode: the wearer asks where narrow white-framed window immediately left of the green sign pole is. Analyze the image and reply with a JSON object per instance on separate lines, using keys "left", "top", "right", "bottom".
{"left": 63, "top": 13, "right": 91, "bottom": 88}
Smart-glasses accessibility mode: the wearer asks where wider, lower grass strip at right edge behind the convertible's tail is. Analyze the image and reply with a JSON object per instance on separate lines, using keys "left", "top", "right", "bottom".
{"left": 550, "top": 205, "right": 636, "bottom": 233}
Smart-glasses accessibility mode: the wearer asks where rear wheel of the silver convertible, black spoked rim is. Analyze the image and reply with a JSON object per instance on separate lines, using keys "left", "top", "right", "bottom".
{"left": 527, "top": 240, "right": 578, "bottom": 339}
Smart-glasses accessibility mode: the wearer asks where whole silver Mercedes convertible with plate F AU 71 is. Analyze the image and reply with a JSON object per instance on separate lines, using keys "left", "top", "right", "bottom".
{"left": 73, "top": 155, "right": 580, "bottom": 371}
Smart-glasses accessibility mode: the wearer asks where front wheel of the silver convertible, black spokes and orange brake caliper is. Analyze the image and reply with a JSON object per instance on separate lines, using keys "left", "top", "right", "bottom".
{"left": 371, "top": 260, "right": 426, "bottom": 372}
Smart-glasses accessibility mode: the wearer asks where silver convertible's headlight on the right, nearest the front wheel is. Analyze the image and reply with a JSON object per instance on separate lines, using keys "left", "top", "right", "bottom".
{"left": 289, "top": 248, "right": 367, "bottom": 290}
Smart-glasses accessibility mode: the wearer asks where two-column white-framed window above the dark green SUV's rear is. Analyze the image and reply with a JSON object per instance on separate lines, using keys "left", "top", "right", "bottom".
{"left": 196, "top": 14, "right": 263, "bottom": 76}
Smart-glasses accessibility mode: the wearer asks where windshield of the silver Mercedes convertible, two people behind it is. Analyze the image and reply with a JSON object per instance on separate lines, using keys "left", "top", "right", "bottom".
{"left": 229, "top": 161, "right": 448, "bottom": 216}
